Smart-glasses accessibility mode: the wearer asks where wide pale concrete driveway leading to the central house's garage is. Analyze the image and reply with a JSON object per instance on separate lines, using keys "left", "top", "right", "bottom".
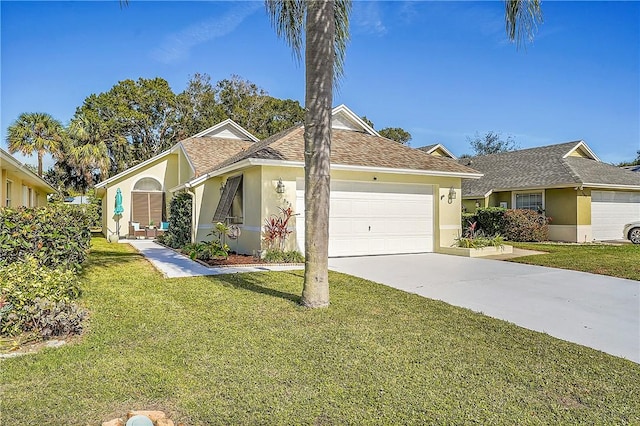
{"left": 329, "top": 253, "right": 640, "bottom": 363}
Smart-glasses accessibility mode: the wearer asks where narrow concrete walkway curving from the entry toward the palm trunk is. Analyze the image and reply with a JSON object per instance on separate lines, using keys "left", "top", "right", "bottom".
{"left": 128, "top": 240, "right": 302, "bottom": 278}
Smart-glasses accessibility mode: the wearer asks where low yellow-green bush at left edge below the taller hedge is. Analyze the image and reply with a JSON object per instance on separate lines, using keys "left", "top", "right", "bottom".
{"left": 0, "top": 257, "right": 82, "bottom": 336}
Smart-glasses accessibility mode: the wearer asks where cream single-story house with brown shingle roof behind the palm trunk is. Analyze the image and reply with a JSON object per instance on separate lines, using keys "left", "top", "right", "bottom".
{"left": 96, "top": 105, "right": 481, "bottom": 256}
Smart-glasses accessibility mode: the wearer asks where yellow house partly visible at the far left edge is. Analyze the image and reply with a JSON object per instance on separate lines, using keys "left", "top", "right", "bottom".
{"left": 0, "top": 148, "right": 57, "bottom": 207}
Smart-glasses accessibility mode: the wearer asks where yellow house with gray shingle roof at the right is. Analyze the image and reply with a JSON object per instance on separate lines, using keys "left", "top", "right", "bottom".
{"left": 459, "top": 141, "right": 640, "bottom": 242}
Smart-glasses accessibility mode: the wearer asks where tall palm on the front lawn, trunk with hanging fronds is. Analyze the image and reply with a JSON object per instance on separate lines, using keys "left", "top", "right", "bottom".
{"left": 265, "top": 0, "right": 542, "bottom": 307}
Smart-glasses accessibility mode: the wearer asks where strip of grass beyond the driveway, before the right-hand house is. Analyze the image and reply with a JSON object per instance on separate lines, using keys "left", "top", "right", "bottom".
{"left": 509, "top": 242, "right": 640, "bottom": 281}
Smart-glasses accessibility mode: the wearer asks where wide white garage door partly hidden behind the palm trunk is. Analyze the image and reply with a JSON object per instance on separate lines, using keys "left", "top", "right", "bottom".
{"left": 296, "top": 181, "right": 433, "bottom": 257}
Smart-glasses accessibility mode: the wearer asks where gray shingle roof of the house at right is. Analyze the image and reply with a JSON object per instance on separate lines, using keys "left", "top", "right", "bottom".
{"left": 459, "top": 141, "right": 640, "bottom": 197}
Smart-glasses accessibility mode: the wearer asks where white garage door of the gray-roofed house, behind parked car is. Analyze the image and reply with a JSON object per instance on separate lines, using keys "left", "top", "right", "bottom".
{"left": 591, "top": 191, "right": 640, "bottom": 240}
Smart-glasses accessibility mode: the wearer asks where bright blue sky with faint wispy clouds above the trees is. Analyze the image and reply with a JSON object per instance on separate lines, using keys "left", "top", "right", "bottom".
{"left": 0, "top": 1, "right": 640, "bottom": 168}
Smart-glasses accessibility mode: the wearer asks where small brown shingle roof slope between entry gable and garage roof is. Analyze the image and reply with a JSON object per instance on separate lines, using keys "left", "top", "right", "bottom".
{"left": 180, "top": 136, "right": 254, "bottom": 177}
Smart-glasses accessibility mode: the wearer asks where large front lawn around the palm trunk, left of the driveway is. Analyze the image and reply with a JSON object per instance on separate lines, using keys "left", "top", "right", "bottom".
{"left": 0, "top": 239, "right": 640, "bottom": 425}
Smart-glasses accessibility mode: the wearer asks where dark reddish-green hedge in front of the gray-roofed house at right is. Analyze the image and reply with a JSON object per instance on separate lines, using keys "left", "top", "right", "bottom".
{"left": 462, "top": 207, "right": 549, "bottom": 242}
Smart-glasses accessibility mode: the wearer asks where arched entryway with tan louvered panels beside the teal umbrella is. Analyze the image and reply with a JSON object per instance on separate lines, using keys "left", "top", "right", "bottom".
{"left": 131, "top": 177, "right": 165, "bottom": 226}
